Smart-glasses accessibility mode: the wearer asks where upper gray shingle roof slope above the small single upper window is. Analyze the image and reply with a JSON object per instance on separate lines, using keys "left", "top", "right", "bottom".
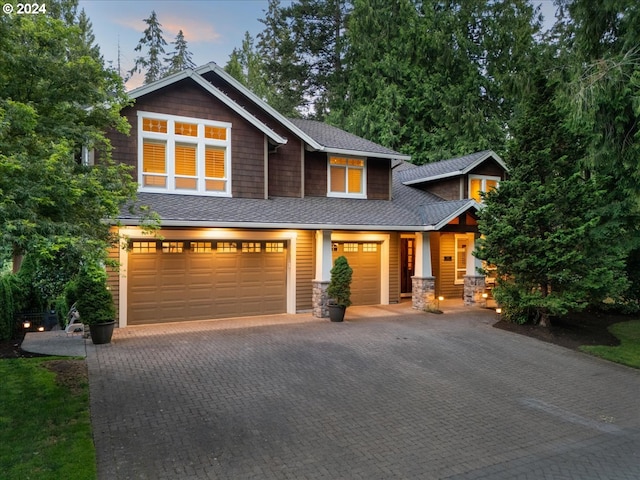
{"left": 289, "top": 118, "right": 410, "bottom": 159}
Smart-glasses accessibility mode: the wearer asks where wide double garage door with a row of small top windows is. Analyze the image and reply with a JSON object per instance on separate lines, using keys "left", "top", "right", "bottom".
{"left": 127, "top": 241, "right": 287, "bottom": 325}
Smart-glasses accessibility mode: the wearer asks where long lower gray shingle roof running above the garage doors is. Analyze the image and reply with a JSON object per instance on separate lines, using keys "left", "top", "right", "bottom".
{"left": 120, "top": 183, "right": 473, "bottom": 230}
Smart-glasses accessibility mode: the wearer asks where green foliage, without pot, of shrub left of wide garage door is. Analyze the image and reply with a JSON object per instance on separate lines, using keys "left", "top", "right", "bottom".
{"left": 69, "top": 265, "right": 116, "bottom": 325}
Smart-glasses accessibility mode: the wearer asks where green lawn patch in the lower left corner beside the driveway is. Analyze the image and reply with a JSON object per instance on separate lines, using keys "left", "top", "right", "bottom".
{"left": 0, "top": 357, "right": 96, "bottom": 480}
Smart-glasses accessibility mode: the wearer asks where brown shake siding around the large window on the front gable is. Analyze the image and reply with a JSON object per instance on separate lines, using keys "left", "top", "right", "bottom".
{"left": 109, "top": 79, "right": 264, "bottom": 198}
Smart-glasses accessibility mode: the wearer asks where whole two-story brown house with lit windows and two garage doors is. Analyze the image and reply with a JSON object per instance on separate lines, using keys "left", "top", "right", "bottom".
{"left": 110, "top": 64, "right": 506, "bottom": 327}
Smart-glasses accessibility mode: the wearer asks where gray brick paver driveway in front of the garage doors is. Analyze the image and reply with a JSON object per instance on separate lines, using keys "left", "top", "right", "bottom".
{"left": 87, "top": 305, "right": 640, "bottom": 480}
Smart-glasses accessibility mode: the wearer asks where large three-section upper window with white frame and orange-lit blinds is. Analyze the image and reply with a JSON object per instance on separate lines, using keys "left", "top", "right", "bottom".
{"left": 138, "top": 112, "right": 231, "bottom": 196}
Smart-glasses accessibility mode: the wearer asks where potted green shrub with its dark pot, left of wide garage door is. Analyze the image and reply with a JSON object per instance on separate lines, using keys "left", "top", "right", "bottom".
{"left": 76, "top": 267, "right": 116, "bottom": 345}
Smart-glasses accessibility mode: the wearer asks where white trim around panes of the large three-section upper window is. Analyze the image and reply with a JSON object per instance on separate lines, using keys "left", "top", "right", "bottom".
{"left": 137, "top": 111, "right": 231, "bottom": 197}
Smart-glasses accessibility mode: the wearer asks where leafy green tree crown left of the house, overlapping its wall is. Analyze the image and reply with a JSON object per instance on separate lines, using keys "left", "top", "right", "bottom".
{"left": 0, "top": 6, "right": 137, "bottom": 278}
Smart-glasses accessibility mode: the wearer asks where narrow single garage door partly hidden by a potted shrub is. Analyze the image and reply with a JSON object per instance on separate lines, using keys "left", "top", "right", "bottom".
{"left": 332, "top": 242, "right": 380, "bottom": 305}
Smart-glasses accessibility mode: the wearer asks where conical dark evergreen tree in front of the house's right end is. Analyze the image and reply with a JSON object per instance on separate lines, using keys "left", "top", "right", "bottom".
{"left": 477, "top": 48, "right": 627, "bottom": 326}
